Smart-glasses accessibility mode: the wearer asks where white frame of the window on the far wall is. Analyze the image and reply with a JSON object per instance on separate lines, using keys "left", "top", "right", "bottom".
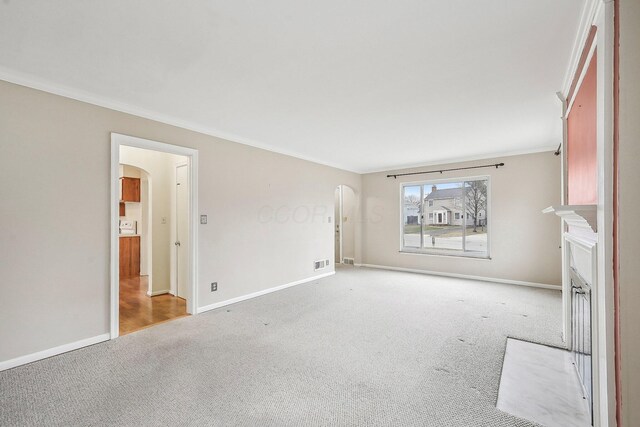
{"left": 398, "top": 175, "right": 493, "bottom": 260}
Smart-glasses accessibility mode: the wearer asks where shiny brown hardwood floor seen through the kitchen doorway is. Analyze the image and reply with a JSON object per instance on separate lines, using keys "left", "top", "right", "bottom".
{"left": 120, "top": 276, "right": 188, "bottom": 335}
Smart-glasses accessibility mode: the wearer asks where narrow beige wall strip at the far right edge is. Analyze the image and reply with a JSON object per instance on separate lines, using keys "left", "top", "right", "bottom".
{"left": 618, "top": 0, "right": 640, "bottom": 427}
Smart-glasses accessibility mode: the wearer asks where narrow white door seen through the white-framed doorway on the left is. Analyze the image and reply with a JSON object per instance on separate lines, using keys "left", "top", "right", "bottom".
{"left": 175, "top": 165, "right": 189, "bottom": 299}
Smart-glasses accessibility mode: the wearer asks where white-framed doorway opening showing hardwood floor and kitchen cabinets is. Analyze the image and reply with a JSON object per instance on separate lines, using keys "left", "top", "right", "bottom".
{"left": 110, "top": 134, "right": 197, "bottom": 339}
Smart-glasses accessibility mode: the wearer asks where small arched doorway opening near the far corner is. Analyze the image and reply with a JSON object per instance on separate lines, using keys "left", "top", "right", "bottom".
{"left": 334, "top": 185, "right": 356, "bottom": 265}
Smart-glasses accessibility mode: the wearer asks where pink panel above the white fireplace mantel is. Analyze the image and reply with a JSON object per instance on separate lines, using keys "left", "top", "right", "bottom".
{"left": 567, "top": 52, "right": 598, "bottom": 205}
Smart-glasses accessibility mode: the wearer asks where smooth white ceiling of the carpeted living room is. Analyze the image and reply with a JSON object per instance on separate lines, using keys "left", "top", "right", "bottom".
{"left": 0, "top": 0, "right": 584, "bottom": 172}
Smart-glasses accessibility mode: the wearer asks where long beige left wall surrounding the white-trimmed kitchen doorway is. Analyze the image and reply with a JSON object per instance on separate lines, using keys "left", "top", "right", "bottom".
{"left": 0, "top": 78, "right": 361, "bottom": 361}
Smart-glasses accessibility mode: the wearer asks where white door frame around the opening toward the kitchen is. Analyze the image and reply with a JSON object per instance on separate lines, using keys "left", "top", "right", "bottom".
{"left": 109, "top": 132, "right": 198, "bottom": 339}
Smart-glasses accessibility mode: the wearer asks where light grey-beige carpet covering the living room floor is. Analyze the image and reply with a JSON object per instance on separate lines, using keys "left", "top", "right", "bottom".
{"left": 0, "top": 268, "right": 561, "bottom": 427}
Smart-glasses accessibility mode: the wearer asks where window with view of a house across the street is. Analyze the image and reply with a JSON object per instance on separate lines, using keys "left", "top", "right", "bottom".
{"left": 401, "top": 177, "right": 490, "bottom": 258}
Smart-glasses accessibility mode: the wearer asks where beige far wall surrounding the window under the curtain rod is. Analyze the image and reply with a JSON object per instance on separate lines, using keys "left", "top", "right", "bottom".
{"left": 361, "top": 153, "right": 561, "bottom": 285}
